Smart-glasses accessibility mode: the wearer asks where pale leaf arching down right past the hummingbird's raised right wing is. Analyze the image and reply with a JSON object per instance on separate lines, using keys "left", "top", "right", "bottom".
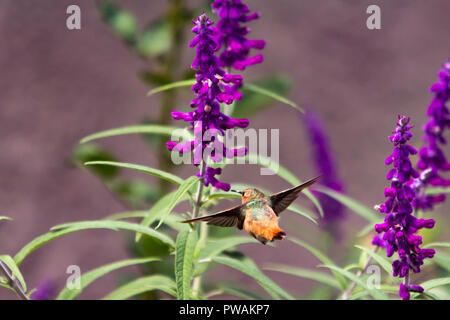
{"left": 246, "top": 153, "right": 323, "bottom": 220}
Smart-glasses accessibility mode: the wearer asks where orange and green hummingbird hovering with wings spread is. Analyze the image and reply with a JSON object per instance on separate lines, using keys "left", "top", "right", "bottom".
{"left": 182, "top": 177, "right": 319, "bottom": 244}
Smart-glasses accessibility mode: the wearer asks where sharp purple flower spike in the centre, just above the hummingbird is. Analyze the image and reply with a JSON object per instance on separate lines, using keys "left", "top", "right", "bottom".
{"left": 167, "top": 14, "right": 249, "bottom": 191}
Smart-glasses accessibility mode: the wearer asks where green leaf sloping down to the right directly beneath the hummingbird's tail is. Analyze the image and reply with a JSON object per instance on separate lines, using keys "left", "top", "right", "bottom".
{"left": 212, "top": 256, "right": 294, "bottom": 300}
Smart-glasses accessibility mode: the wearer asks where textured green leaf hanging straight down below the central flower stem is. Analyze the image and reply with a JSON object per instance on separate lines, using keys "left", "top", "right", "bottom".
{"left": 175, "top": 229, "right": 198, "bottom": 300}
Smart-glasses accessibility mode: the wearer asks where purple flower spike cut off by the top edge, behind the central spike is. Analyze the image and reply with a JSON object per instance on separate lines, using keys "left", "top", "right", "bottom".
{"left": 212, "top": 0, "right": 266, "bottom": 70}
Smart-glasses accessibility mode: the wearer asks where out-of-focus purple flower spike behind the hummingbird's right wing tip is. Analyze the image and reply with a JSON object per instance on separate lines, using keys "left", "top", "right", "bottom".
{"left": 304, "top": 111, "right": 345, "bottom": 235}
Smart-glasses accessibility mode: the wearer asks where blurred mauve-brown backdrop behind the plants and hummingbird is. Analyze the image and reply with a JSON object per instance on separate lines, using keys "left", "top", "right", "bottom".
{"left": 0, "top": 0, "right": 450, "bottom": 299}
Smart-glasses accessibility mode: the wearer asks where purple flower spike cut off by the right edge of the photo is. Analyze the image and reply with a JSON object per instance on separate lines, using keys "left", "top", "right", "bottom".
{"left": 412, "top": 61, "right": 450, "bottom": 210}
